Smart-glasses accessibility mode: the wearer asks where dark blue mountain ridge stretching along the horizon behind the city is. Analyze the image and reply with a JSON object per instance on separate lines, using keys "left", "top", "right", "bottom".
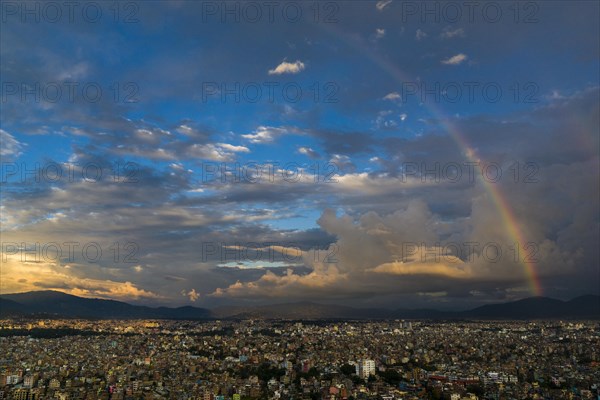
{"left": 0, "top": 290, "right": 600, "bottom": 320}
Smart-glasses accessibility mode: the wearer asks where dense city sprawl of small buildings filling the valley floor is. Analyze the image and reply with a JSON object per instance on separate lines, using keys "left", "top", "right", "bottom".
{"left": 0, "top": 319, "right": 600, "bottom": 400}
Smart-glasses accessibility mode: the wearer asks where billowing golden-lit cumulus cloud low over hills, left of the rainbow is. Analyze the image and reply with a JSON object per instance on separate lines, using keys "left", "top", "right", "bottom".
{"left": 211, "top": 202, "right": 470, "bottom": 298}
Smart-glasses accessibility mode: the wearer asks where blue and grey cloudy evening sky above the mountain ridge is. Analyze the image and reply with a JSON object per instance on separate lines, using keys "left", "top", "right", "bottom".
{"left": 0, "top": 0, "right": 600, "bottom": 309}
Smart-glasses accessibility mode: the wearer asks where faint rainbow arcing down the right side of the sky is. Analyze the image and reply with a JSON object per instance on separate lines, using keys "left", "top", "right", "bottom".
{"left": 318, "top": 24, "right": 543, "bottom": 296}
